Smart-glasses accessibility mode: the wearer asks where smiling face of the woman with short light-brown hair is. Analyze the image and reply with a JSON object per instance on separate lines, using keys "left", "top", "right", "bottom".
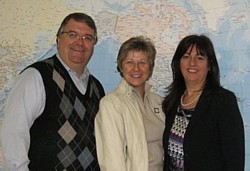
{"left": 122, "top": 51, "right": 151, "bottom": 93}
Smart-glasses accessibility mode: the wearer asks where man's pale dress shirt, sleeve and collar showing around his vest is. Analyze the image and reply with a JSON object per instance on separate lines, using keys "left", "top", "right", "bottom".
{"left": 1, "top": 55, "right": 89, "bottom": 171}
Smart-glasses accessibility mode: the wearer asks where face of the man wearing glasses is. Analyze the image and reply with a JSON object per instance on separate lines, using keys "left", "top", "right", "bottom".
{"left": 57, "top": 19, "right": 95, "bottom": 75}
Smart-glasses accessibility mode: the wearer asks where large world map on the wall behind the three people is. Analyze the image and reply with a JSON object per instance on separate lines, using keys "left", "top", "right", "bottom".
{"left": 0, "top": 0, "right": 250, "bottom": 171}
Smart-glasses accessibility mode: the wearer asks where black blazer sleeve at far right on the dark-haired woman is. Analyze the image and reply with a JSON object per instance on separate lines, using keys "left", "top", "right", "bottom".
{"left": 217, "top": 91, "right": 245, "bottom": 171}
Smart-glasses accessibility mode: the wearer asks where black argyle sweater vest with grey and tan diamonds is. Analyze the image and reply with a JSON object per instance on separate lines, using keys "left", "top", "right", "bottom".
{"left": 28, "top": 56, "right": 104, "bottom": 171}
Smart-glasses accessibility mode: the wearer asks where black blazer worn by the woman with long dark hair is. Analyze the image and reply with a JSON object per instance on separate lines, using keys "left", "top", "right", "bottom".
{"left": 163, "top": 88, "right": 245, "bottom": 171}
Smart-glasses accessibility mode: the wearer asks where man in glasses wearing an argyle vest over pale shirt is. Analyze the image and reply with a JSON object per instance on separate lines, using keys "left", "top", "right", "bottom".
{"left": 2, "top": 13, "right": 104, "bottom": 171}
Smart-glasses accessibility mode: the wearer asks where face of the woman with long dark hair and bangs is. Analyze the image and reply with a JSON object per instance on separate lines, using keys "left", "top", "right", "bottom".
{"left": 180, "top": 45, "right": 209, "bottom": 88}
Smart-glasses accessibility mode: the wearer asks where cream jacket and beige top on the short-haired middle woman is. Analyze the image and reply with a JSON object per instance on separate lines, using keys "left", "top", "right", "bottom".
{"left": 95, "top": 79, "right": 165, "bottom": 171}
